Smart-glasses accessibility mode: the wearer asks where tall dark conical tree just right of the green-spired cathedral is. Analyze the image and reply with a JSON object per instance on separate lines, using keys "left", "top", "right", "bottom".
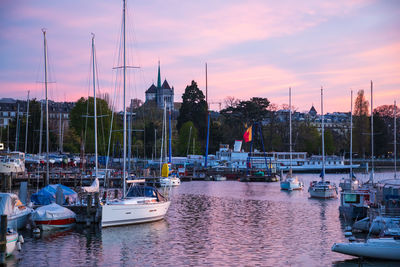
{"left": 177, "top": 81, "right": 208, "bottom": 142}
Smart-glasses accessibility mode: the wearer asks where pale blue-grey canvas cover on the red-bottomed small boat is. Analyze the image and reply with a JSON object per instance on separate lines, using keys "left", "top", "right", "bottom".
{"left": 32, "top": 203, "right": 75, "bottom": 221}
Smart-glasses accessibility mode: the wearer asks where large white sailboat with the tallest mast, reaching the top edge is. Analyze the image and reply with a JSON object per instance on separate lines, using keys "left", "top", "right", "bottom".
{"left": 101, "top": 0, "right": 171, "bottom": 227}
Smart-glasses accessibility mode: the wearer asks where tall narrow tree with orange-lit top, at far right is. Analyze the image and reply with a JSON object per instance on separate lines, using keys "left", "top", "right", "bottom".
{"left": 353, "top": 90, "right": 370, "bottom": 157}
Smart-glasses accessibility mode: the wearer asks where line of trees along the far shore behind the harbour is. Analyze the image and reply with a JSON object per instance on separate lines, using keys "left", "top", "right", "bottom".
{"left": 0, "top": 85, "right": 400, "bottom": 159}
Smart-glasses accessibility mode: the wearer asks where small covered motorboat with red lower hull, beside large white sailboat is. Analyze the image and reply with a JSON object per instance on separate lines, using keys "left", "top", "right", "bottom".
{"left": 32, "top": 203, "right": 76, "bottom": 231}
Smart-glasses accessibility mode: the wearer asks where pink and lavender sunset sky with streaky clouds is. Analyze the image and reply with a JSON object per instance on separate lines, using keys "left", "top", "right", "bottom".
{"left": 0, "top": 0, "right": 400, "bottom": 112}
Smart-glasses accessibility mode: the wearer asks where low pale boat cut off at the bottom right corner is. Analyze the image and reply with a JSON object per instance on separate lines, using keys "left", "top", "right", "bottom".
{"left": 332, "top": 237, "right": 400, "bottom": 260}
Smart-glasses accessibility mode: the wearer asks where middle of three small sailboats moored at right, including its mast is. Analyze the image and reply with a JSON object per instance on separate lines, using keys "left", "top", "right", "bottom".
{"left": 308, "top": 87, "right": 337, "bottom": 199}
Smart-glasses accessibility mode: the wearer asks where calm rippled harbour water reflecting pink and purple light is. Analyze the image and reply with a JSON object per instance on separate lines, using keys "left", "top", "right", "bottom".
{"left": 8, "top": 173, "right": 398, "bottom": 266}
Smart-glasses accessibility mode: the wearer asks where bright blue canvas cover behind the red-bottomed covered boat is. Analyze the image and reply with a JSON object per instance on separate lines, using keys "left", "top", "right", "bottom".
{"left": 31, "top": 184, "right": 78, "bottom": 205}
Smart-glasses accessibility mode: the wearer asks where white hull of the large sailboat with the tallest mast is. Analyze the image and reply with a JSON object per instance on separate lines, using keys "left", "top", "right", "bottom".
{"left": 101, "top": 201, "right": 171, "bottom": 227}
